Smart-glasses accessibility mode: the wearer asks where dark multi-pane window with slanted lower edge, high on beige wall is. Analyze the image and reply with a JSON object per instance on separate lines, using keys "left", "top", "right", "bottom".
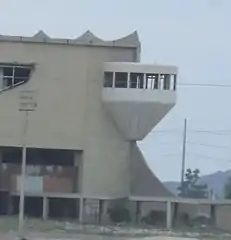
{"left": 0, "top": 65, "right": 32, "bottom": 89}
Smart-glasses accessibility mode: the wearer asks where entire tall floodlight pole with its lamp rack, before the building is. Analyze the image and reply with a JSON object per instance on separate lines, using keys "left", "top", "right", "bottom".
{"left": 18, "top": 90, "right": 37, "bottom": 235}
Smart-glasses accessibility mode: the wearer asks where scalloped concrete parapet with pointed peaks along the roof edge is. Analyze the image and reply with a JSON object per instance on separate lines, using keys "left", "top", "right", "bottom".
{"left": 0, "top": 30, "right": 140, "bottom": 48}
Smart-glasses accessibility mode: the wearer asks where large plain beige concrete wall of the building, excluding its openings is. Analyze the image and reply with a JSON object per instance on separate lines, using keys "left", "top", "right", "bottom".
{"left": 0, "top": 42, "right": 136, "bottom": 197}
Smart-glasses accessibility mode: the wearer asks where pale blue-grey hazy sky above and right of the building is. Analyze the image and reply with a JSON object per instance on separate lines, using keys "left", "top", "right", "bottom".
{"left": 0, "top": 0, "right": 231, "bottom": 181}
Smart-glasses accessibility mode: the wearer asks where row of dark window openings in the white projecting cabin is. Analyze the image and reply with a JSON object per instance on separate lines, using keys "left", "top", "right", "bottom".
{"left": 104, "top": 71, "right": 177, "bottom": 91}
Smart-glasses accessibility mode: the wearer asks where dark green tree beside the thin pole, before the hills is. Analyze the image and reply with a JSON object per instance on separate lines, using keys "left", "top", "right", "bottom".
{"left": 178, "top": 168, "right": 208, "bottom": 198}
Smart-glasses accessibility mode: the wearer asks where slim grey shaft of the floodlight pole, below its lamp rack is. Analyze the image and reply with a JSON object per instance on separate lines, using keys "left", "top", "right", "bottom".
{"left": 19, "top": 111, "right": 28, "bottom": 234}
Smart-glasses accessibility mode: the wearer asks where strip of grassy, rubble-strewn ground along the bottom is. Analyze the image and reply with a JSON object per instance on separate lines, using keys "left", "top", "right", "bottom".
{"left": 0, "top": 217, "right": 231, "bottom": 240}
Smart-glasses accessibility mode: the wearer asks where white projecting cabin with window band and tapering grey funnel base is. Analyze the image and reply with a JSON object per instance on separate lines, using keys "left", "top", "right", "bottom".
{"left": 102, "top": 62, "right": 178, "bottom": 141}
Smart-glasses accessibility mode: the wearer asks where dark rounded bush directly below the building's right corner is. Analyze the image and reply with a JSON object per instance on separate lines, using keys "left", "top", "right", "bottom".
{"left": 108, "top": 206, "right": 131, "bottom": 223}
